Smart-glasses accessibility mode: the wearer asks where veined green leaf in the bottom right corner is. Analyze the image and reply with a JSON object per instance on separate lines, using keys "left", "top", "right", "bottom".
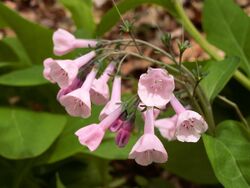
{"left": 203, "top": 120, "right": 250, "bottom": 188}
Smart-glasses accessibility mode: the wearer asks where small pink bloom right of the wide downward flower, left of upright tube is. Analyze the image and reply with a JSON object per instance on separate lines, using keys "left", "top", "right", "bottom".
{"left": 90, "top": 63, "right": 115, "bottom": 105}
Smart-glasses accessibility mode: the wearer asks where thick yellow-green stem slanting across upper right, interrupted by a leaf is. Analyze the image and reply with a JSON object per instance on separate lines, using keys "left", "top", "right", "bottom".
{"left": 174, "top": 0, "right": 250, "bottom": 90}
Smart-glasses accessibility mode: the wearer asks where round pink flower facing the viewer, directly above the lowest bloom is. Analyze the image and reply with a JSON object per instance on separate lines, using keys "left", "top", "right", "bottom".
{"left": 138, "top": 68, "right": 175, "bottom": 108}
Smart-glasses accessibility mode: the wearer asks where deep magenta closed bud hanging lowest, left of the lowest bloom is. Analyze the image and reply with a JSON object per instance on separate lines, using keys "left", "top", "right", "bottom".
{"left": 115, "top": 117, "right": 134, "bottom": 148}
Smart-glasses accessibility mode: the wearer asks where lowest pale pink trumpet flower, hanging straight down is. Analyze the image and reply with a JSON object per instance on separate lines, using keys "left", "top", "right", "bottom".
{"left": 129, "top": 107, "right": 168, "bottom": 166}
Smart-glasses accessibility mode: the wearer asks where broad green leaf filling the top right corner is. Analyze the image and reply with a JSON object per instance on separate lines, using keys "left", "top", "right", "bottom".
{"left": 203, "top": 0, "right": 250, "bottom": 77}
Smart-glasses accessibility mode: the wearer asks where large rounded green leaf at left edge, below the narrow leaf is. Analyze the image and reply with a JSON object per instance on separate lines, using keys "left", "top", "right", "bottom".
{"left": 0, "top": 108, "right": 66, "bottom": 159}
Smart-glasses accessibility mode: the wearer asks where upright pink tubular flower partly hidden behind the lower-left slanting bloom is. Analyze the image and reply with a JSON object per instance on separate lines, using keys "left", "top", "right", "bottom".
{"left": 99, "top": 76, "right": 121, "bottom": 120}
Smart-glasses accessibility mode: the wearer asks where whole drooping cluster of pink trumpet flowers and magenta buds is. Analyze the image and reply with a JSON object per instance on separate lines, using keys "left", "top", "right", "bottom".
{"left": 43, "top": 29, "right": 208, "bottom": 166}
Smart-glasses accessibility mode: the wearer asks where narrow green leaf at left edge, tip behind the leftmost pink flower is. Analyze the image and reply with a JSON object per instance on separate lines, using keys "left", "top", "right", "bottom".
{"left": 0, "top": 65, "right": 48, "bottom": 86}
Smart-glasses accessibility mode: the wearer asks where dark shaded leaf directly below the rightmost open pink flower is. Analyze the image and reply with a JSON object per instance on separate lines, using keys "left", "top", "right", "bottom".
{"left": 165, "top": 141, "right": 218, "bottom": 184}
